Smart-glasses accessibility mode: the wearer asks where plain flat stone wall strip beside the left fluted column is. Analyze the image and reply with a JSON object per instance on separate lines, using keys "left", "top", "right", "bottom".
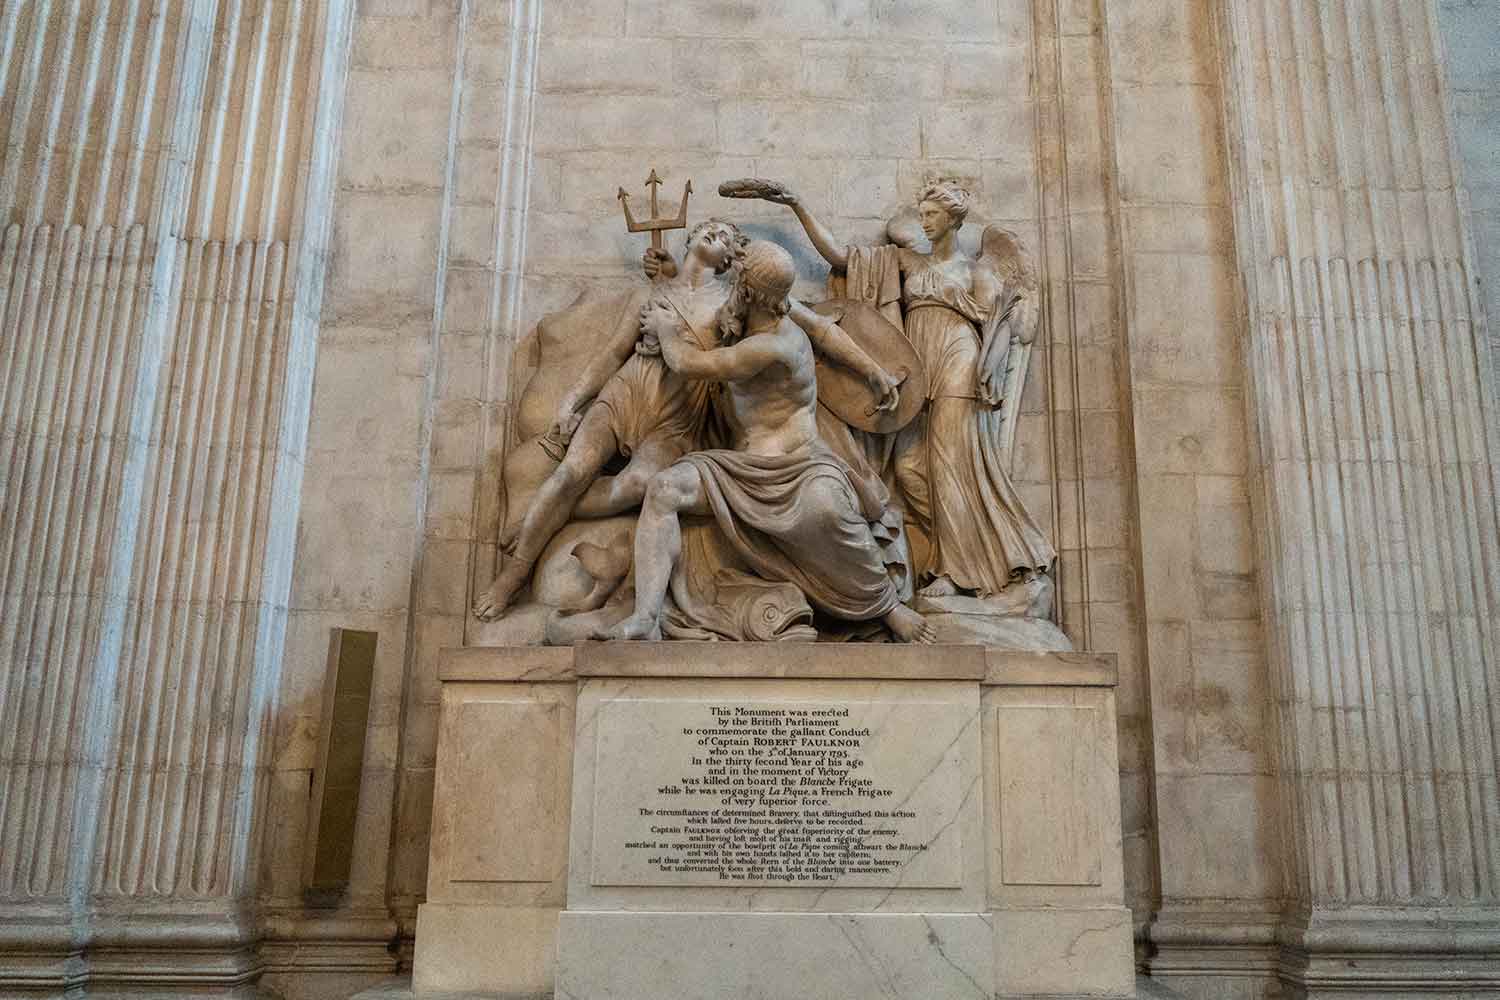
{"left": 263, "top": 0, "right": 458, "bottom": 996}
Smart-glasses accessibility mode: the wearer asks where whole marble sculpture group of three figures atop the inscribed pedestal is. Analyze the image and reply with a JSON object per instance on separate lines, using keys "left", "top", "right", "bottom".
{"left": 474, "top": 172, "right": 1068, "bottom": 649}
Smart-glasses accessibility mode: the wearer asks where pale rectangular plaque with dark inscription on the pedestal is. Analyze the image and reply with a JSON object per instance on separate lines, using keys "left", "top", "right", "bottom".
{"left": 591, "top": 699, "right": 972, "bottom": 888}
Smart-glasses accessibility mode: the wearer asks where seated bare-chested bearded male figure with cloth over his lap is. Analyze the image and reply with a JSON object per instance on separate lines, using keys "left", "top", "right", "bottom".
{"left": 597, "top": 240, "right": 936, "bottom": 643}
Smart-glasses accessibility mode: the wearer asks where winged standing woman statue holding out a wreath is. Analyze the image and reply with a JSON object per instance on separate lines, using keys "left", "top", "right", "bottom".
{"left": 720, "top": 180, "right": 1056, "bottom": 597}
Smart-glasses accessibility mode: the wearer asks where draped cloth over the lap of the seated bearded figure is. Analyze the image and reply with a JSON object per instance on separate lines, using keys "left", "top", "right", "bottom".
{"left": 665, "top": 442, "right": 906, "bottom": 636}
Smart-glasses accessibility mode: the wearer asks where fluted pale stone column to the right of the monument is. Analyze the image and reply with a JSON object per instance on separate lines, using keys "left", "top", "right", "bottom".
{"left": 1220, "top": 0, "right": 1500, "bottom": 996}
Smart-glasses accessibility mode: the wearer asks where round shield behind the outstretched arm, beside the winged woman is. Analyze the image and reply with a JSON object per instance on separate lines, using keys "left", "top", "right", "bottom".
{"left": 810, "top": 298, "right": 927, "bottom": 433}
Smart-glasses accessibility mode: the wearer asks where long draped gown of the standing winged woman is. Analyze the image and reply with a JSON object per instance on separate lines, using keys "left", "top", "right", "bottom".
{"left": 896, "top": 253, "right": 1056, "bottom": 597}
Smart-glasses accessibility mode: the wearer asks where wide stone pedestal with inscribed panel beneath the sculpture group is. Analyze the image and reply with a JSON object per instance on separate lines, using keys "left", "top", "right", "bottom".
{"left": 414, "top": 643, "right": 1134, "bottom": 999}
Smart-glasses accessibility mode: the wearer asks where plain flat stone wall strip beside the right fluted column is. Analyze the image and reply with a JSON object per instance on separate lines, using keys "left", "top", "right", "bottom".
{"left": 1103, "top": 0, "right": 1281, "bottom": 997}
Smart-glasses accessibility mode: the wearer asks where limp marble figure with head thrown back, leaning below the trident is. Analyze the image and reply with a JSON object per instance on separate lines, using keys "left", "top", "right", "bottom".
{"left": 474, "top": 220, "right": 900, "bottom": 621}
